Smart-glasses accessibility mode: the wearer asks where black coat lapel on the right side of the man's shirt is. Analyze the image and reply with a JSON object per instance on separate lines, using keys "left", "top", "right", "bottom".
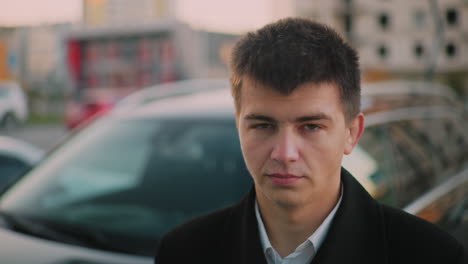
{"left": 312, "top": 169, "right": 388, "bottom": 264}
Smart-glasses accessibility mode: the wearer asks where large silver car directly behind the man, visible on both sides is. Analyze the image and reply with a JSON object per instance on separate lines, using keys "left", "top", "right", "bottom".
{"left": 0, "top": 79, "right": 468, "bottom": 264}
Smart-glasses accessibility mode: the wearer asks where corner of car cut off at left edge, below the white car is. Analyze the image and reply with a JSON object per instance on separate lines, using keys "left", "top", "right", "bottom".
{"left": 0, "top": 136, "right": 44, "bottom": 190}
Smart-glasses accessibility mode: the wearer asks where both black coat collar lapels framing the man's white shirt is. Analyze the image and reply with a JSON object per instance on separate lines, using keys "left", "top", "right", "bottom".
{"left": 232, "top": 169, "right": 387, "bottom": 264}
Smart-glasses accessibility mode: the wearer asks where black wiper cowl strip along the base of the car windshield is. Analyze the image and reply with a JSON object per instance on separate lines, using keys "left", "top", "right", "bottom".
{"left": 0, "top": 212, "right": 144, "bottom": 254}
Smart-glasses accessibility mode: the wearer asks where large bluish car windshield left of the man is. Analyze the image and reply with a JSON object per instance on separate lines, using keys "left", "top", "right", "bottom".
{"left": 1, "top": 116, "right": 251, "bottom": 255}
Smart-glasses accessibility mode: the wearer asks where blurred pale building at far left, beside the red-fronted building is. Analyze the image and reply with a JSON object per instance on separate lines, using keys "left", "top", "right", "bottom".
{"left": 8, "top": 23, "right": 71, "bottom": 115}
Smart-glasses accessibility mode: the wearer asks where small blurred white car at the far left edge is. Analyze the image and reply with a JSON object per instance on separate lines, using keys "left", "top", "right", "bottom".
{"left": 0, "top": 81, "right": 28, "bottom": 130}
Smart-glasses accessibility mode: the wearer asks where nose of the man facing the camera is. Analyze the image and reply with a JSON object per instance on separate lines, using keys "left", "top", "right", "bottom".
{"left": 271, "top": 129, "right": 299, "bottom": 163}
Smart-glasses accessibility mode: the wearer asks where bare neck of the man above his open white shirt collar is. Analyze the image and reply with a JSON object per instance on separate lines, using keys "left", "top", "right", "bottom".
{"left": 257, "top": 180, "right": 340, "bottom": 257}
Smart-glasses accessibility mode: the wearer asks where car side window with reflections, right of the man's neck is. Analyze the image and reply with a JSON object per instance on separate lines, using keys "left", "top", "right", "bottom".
{"left": 352, "top": 114, "right": 468, "bottom": 208}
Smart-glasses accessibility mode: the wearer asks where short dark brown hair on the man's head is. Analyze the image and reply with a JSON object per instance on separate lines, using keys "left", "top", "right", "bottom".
{"left": 230, "top": 18, "right": 361, "bottom": 120}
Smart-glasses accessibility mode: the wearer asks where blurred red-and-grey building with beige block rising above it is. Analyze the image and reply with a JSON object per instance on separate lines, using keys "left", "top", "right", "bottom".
{"left": 66, "top": 0, "right": 237, "bottom": 98}
